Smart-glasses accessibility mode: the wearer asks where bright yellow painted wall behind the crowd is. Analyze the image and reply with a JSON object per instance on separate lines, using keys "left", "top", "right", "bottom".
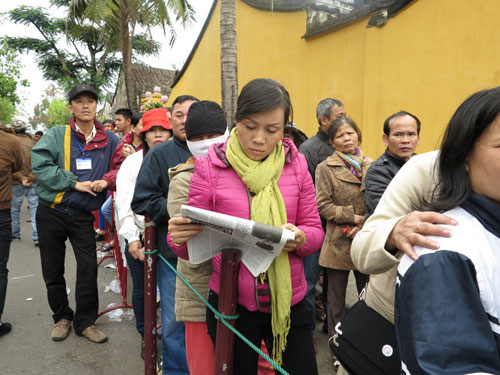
{"left": 170, "top": 0, "right": 500, "bottom": 158}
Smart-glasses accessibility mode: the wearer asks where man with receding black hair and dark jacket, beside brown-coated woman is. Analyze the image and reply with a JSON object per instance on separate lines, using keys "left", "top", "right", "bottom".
{"left": 365, "top": 111, "right": 420, "bottom": 217}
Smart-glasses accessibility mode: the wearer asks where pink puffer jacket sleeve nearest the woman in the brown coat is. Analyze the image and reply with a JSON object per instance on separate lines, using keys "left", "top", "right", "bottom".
{"left": 294, "top": 154, "right": 325, "bottom": 256}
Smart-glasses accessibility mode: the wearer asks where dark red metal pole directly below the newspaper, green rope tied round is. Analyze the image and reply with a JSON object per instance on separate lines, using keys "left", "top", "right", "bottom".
{"left": 214, "top": 249, "right": 241, "bottom": 375}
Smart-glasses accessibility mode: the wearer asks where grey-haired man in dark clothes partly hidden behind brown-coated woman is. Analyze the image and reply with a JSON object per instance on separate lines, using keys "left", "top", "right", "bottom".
{"left": 299, "top": 98, "right": 346, "bottom": 330}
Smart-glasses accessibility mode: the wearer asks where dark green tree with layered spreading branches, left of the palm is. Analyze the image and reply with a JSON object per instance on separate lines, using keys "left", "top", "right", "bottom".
{"left": 3, "top": 0, "right": 160, "bottom": 91}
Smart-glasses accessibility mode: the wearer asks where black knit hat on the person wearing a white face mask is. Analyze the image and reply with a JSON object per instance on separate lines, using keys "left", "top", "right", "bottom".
{"left": 185, "top": 100, "right": 227, "bottom": 140}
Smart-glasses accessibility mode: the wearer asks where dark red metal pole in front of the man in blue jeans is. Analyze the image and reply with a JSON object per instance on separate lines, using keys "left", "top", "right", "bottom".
{"left": 144, "top": 216, "right": 156, "bottom": 375}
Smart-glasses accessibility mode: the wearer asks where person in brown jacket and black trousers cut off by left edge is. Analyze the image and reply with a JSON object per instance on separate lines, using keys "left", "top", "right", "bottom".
{"left": 0, "top": 127, "right": 23, "bottom": 336}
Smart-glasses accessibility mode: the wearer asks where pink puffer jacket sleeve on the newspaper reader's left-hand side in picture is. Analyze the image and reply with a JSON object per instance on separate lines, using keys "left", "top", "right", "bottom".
{"left": 167, "top": 156, "right": 213, "bottom": 260}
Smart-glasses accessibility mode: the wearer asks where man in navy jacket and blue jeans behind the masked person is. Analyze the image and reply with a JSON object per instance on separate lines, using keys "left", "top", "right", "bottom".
{"left": 132, "top": 95, "right": 198, "bottom": 375}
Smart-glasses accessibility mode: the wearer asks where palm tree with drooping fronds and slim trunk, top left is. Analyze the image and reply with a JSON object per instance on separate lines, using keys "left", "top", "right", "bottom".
{"left": 69, "top": 0, "right": 194, "bottom": 112}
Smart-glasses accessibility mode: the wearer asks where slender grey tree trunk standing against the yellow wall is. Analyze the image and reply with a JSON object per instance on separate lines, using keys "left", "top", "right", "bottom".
{"left": 220, "top": 0, "right": 238, "bottom": 127}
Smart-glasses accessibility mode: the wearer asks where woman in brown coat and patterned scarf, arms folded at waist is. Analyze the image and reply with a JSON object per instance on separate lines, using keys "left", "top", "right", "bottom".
{"left": 316, "top": 117, "right": 372, "bottom": 344}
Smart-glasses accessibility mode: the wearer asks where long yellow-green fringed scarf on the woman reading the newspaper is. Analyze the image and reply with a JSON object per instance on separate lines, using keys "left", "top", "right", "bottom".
{"left": 226, "top": 128, "right": 292, "bottom": 365}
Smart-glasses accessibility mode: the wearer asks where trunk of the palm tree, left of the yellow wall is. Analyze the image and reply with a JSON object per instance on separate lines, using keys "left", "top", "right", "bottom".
{"left": 120, "top": 0, "right": 139, "bottom": 113}
